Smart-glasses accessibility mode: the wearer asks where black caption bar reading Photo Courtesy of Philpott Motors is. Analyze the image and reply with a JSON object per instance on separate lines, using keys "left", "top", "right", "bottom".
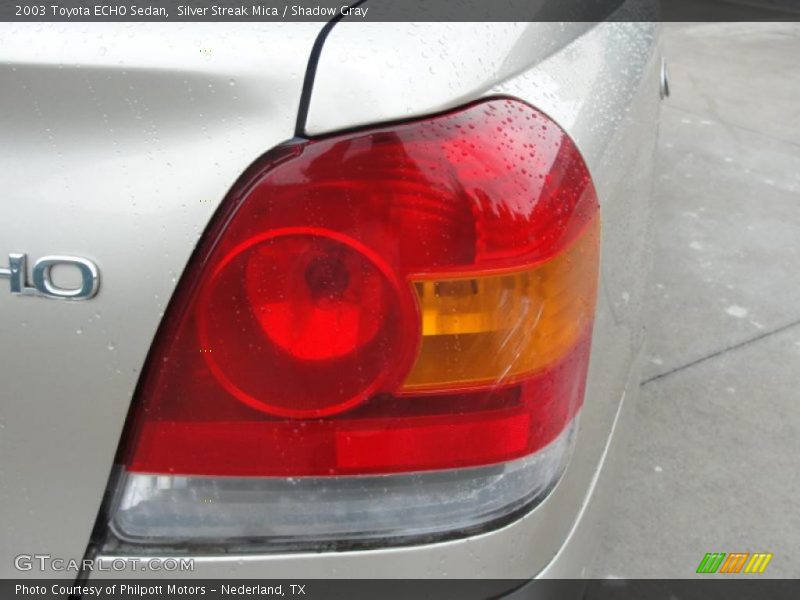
{"left": 0, "top": 575, "right": 800, "bottom": 600}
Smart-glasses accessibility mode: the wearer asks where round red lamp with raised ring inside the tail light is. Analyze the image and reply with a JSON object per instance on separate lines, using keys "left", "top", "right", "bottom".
{"left": 198, "top": 227, "right": 419, "bottom": 418}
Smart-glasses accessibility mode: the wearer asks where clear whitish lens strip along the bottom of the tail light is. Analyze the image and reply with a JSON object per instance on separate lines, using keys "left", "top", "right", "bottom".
{"left": 111, "top": 422, "right": 575, "bottom": 551}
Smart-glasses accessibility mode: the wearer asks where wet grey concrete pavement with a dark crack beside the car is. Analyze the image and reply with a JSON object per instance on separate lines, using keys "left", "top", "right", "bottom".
{"left": 594, "top": 23, "right": 800, "bottom": 578}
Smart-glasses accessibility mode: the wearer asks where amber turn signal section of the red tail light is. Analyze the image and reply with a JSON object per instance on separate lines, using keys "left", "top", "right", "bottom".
{"left": 402, "top": 216, "right": 600, "bottom": 393}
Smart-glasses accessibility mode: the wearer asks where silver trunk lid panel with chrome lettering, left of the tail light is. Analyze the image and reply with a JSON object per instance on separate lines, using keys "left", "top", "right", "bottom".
{"left": 0, "top": 23, "right": 322, "bottom": 577}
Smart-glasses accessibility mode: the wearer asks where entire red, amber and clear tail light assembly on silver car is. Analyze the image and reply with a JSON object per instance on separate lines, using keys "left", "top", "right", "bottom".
{"left": 106, "top": 99, "right": 599, "bottom": 548}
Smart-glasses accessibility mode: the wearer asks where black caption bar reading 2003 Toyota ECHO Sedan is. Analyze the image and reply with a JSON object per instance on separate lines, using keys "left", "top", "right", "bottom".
{"left": 0, "top": 0, "right": 800, "bottom": 23}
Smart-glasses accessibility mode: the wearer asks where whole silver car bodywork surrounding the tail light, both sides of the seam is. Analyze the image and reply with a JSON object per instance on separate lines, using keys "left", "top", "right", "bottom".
{"left": 0, "top": 23, "right": 660, "bottom": 578}
